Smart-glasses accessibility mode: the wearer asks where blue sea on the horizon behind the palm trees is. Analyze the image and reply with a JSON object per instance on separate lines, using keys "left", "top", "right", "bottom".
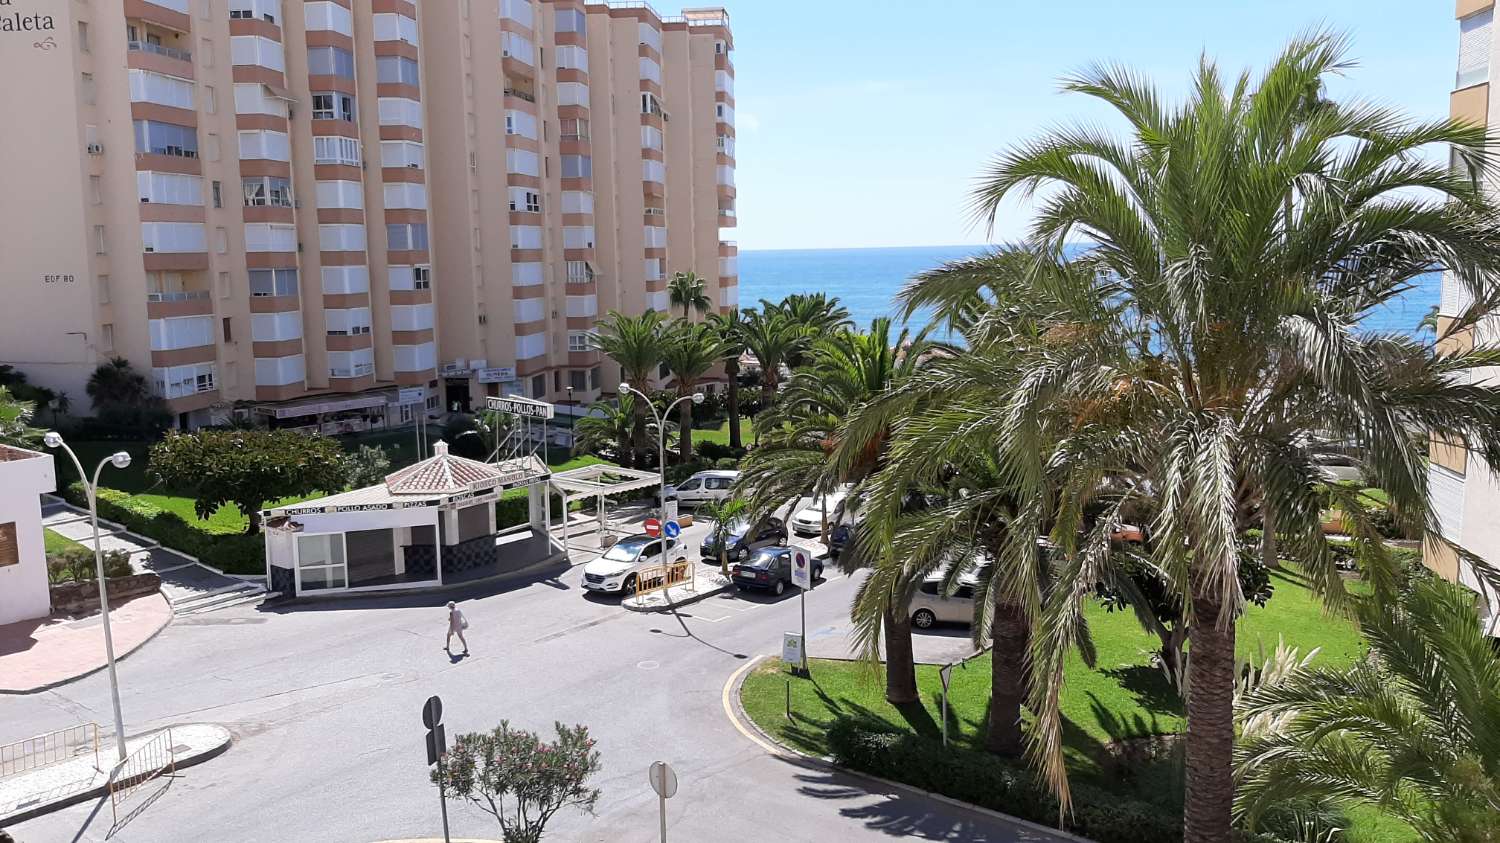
{"left": 740, "top": 246, "right": 1442, "bottom": 336}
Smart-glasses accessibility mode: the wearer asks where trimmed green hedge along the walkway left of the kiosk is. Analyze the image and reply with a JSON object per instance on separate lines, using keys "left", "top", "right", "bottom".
{"left": 63, "top": 483, "right": 266, "bottom": 575}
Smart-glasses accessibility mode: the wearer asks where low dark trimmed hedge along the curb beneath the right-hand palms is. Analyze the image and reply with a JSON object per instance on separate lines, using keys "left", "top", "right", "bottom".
{"left": 828, "top": 719, "right": 1275, "bottom": 843}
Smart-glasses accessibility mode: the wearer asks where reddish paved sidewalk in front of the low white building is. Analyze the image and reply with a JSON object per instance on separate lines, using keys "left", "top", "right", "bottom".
{"left": 0, "top": 594, "right": 173, "bottom": 695}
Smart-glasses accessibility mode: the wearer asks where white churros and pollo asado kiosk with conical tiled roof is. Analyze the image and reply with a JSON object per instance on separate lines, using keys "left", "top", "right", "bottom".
{"left": 261, "top": 443, "right": 564, "bottom": 597}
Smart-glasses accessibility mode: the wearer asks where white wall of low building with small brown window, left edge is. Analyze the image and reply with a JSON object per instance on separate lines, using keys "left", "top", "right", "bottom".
{"left": 0, "top": 446, "right": 57, "bottom": 624}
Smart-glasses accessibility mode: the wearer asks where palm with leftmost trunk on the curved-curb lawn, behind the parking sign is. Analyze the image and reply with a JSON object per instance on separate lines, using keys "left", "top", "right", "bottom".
{"left": 740, "top": 318, "right": 929, "bottom": 704}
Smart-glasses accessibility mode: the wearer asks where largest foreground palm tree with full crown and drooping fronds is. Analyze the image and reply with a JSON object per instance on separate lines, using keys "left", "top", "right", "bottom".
{"left": 948, "top": 35, "right": 1500, "bottom": 843}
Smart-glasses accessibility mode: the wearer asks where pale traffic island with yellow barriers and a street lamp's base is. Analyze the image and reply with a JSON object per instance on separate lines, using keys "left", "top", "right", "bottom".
{"left": 0, "top": 723, "right": 231, "bottom": 828}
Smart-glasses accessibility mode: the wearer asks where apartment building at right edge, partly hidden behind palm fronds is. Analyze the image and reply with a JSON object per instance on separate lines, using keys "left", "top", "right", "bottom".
{"left": 1422, "top": 0, "right": 1500, "bottom": 636}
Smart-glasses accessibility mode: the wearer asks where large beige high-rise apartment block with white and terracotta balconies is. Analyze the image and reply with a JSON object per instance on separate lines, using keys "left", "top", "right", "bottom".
{"left": 0, "top": 0, "right": 738, "bottom": 432}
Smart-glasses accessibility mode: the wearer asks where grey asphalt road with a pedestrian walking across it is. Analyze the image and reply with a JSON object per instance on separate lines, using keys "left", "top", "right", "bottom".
{"left": 0, "top": 519, "right": 1068, "bottom": 843}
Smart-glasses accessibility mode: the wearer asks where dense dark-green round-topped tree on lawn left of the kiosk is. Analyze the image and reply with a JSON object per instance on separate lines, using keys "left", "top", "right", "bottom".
{"left": 149, "top": 431, "right": 348, "bottom": 534}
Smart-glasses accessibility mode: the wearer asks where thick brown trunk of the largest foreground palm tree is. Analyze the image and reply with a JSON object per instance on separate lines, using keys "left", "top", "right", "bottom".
{"left": 1182, "top": 594, "right": 1235, "bottom": 843}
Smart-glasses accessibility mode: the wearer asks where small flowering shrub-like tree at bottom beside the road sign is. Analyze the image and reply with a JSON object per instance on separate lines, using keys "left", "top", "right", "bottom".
{"left": 432, "top": 720, "right": 600, "bottom": 843}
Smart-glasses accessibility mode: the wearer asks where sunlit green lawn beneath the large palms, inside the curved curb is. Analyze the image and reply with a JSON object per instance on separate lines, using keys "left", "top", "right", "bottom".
{"left": 741, "top": 572, "right": 1413, "bottom": 843}
